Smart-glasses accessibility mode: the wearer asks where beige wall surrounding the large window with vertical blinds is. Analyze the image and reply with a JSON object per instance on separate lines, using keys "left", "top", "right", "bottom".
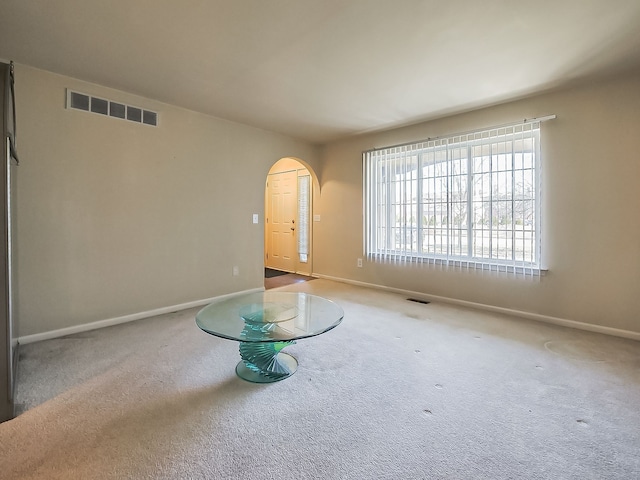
{"left": 314, "top": 70, "right": 640, "bottom": 332}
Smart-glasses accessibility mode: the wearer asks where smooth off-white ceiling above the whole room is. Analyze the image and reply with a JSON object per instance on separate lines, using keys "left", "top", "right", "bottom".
{"left": 0, "top": 0, "right": 640, "bottom": 143}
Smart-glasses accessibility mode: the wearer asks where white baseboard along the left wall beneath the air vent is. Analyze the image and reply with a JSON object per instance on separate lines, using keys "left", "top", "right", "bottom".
{"left": 18, "top": 287, "right": 264, "bottom": 345}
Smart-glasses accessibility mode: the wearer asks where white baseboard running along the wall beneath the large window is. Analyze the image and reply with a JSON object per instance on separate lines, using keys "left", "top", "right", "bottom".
{"left": 313, "top": 273, "right": 640, "bottom": 341}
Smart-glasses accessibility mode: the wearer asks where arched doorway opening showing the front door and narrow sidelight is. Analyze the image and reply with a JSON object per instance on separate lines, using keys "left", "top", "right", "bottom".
{"left": 264, "top": 157, "right": 317, "bottom": 275}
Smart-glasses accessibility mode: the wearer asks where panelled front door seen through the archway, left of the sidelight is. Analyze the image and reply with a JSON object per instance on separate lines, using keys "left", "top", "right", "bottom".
{"left": 265, "top": 171, "right": 298, "bottom": 272}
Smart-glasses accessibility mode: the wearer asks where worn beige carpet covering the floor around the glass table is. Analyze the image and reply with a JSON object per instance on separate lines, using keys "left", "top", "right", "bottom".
{"left": 0, "top": 280, "right": 640, "bottom": 479}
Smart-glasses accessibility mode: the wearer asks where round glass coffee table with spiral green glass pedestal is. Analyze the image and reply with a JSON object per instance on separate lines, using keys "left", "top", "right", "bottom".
{"left": 196, "top": 290, "right": 344, "bottom": 383}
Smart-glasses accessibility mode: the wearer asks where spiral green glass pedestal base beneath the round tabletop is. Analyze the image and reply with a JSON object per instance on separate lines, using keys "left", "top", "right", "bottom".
{"left": 236, "top": 341, "right": 298, "bottom": 383}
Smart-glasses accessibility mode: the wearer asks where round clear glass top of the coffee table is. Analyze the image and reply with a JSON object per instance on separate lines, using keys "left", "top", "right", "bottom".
{"left": 196, "top": 290, "right": 344, "bottom": 342}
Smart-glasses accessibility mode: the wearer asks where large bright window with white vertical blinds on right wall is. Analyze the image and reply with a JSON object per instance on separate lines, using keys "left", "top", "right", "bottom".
{"left": 364, "top": 117, "right": 553, "bottom": 274}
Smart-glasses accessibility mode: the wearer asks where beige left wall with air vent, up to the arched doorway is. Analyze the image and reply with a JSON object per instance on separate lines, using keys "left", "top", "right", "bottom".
{"left": 16, "top": 65, "right": 318, "bottom": 336}
